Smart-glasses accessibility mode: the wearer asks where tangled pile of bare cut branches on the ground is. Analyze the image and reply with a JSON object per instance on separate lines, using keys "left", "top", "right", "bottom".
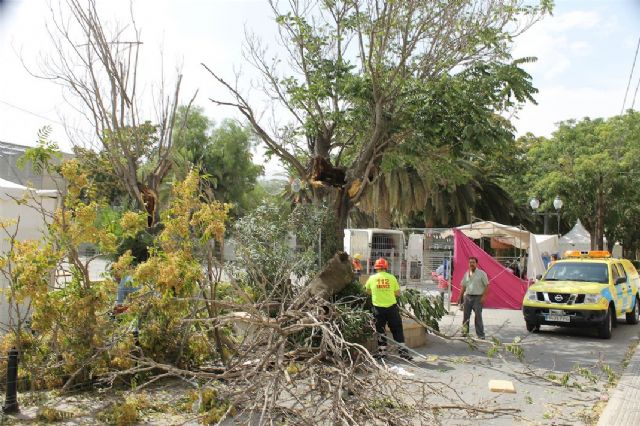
{"left": 105, "top": 248, "right": 515, "bottom": 424}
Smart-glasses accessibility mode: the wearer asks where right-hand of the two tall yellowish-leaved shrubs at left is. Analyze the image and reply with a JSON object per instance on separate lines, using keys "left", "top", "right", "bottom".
{"left": 125, "top": 172, "right": 230, "bottom": 365}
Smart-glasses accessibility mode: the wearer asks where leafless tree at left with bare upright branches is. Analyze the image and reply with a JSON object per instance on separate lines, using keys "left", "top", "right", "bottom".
{"left": 40, "top": 0, "right": 188, "bottom": 225}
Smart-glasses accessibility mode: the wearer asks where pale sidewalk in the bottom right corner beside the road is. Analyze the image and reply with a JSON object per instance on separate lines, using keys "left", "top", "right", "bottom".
{"left": 598, "top": 340, "right": 640, "bottom": 426}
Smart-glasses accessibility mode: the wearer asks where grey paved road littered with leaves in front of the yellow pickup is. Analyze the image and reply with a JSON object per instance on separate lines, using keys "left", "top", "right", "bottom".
{"left": 407, "top": 307, "right": 640, "bottom": 425}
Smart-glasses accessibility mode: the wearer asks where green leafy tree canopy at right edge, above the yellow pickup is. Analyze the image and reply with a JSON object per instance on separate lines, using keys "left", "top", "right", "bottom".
{"left": 504, "top": 111, "right": 640, "bottom": 256}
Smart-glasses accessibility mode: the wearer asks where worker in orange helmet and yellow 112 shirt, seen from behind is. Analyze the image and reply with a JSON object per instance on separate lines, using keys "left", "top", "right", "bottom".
{"left": 365, "top": 257, "right": 413, "bottom": 361}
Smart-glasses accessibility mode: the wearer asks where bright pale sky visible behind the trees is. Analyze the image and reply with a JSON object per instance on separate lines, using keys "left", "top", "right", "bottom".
{"left": 0, "top": 0, "right": 640, "bottom": 175}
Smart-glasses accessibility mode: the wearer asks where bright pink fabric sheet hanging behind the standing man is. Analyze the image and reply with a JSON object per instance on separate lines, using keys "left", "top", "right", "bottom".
{"left": 451, "top": 229, "right": 527, "bottom": 309}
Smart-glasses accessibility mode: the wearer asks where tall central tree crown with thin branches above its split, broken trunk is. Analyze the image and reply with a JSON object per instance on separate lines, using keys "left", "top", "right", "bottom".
{"left": 204, "top": 0, "right": 550, "bottom": 241}
